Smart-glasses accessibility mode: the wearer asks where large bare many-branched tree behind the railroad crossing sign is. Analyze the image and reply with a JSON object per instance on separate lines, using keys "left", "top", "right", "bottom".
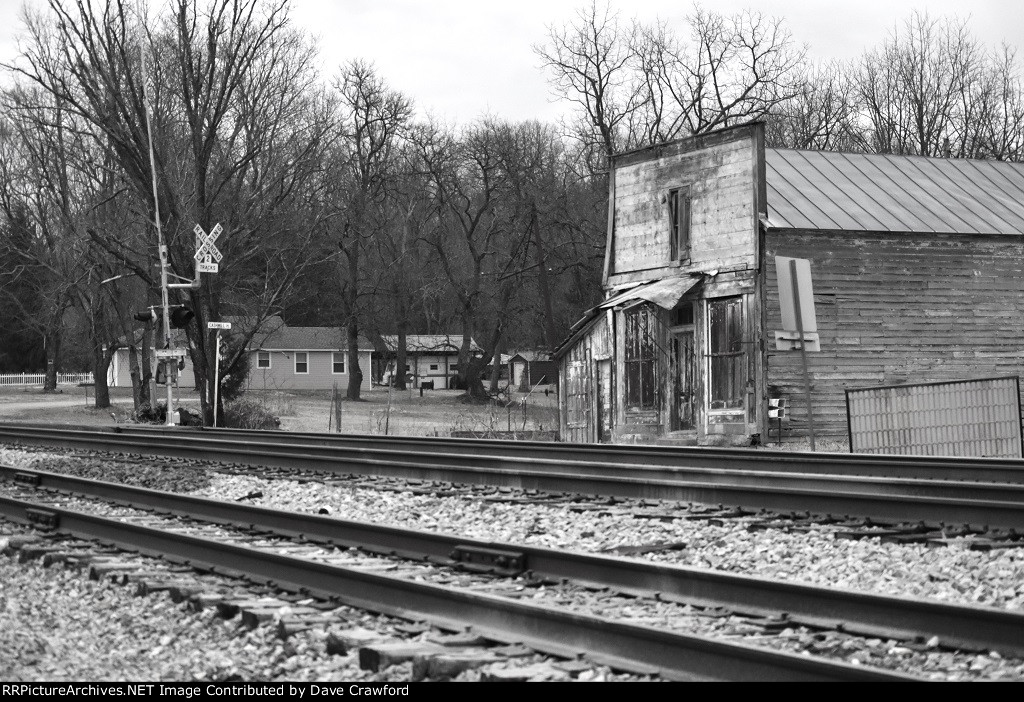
{"left": 8, "top": 0, "right": 331, "bottom": 423}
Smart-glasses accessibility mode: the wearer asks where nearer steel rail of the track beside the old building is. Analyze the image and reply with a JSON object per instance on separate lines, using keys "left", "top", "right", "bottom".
{"left": 6, "top": 427, "right": 1024, "bottom": 529}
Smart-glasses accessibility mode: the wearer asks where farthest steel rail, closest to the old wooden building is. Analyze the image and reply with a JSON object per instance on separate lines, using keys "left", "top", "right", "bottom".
{"left": 114, "top": 425, "right": 1024, "bottom": 483}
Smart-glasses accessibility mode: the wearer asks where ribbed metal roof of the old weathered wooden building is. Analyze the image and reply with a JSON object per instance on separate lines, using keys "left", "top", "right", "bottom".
{"left": 765, "top": 148, "right": 1024, "bottom": 234}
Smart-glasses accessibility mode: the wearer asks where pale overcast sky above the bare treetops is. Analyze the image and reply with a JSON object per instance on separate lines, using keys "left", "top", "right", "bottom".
{"left": 0, "top": 0, "right": 1024, "bottom": 122}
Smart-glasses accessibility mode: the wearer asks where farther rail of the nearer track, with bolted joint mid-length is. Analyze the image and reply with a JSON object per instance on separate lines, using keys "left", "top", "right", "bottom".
{"left": 8, "top": 466, "right": 1024, "bottom": 656}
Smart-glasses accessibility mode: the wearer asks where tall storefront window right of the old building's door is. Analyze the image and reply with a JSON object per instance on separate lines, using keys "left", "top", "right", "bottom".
{"left": 708, "top": 298, "right": 746, "bottom": 409}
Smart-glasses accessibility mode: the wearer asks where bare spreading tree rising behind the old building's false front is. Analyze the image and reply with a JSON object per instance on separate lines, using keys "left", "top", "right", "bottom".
{"left": 535, "top": 4, "right": 806, "bottom": 164}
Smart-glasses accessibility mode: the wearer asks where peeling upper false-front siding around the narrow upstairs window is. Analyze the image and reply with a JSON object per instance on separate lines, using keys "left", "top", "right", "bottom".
{"left": 606, "top": 125, "right": 763, "bottom": 286}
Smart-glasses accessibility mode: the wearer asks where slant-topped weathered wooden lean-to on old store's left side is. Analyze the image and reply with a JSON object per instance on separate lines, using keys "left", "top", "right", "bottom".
{"left": 558, "top": 313, "right": 613, "bottom": 443}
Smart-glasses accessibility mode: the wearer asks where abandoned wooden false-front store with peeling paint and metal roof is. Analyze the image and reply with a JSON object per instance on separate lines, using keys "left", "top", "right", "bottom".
{"left": 556, "top": 123, "right": 1024, "bottom": 444}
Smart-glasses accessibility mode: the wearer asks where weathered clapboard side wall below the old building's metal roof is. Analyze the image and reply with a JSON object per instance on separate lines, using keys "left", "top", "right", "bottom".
{"left": 764, "top": 230, "right": 1024, "bottom": 436}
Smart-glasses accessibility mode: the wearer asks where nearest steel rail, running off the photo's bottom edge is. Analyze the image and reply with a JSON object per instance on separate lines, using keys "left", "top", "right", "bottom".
{"left": 0, "top": 497, "right": 921, "bottom": 682}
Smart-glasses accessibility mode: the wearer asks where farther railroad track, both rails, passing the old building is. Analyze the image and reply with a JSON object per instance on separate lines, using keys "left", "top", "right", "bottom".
{"left": 6, "top": 424, "right": 1024, "bottom": 531}
